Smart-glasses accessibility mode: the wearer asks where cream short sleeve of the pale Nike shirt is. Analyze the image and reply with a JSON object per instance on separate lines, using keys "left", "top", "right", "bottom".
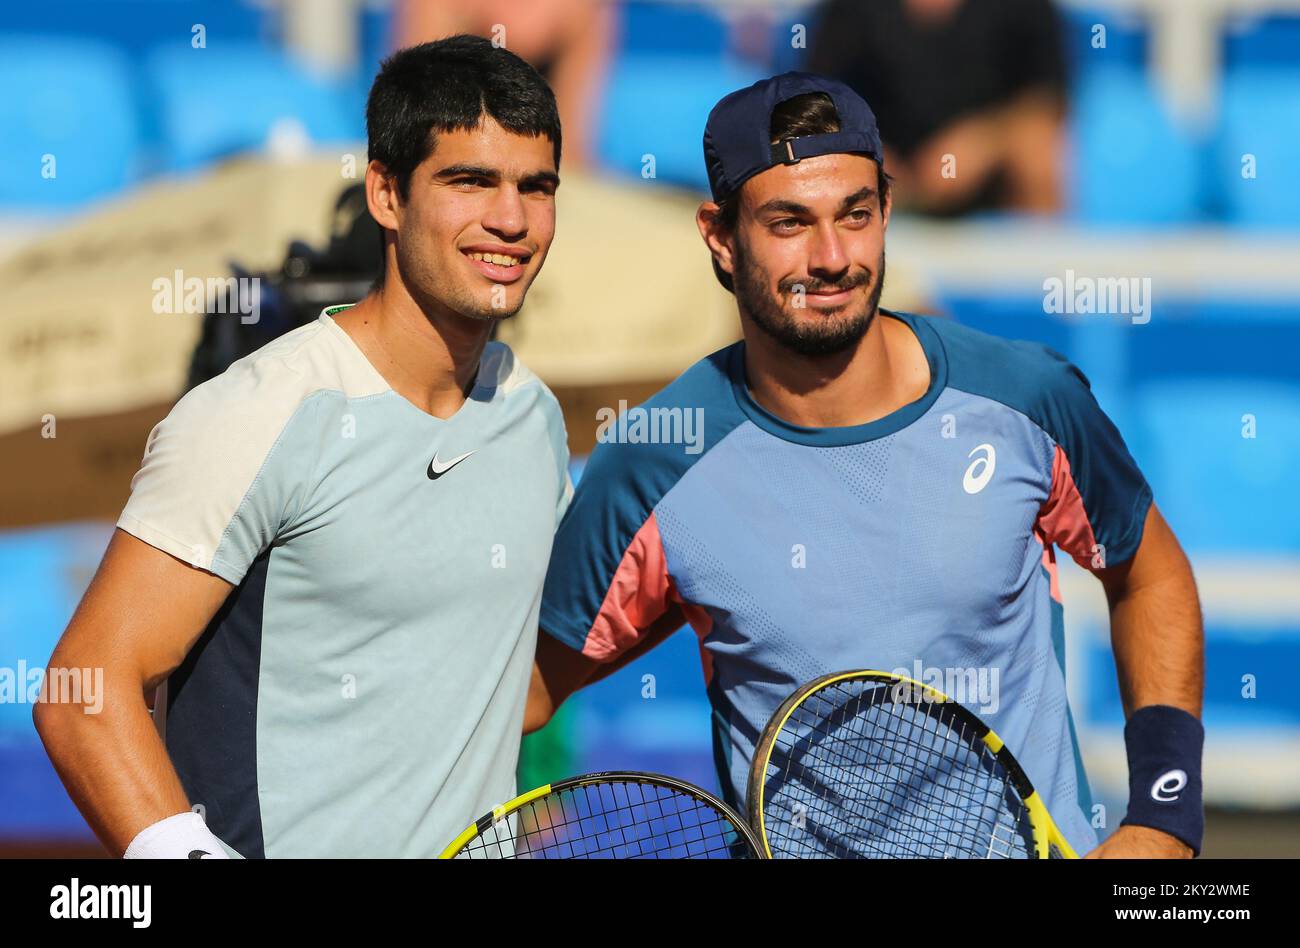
{"left": 117, "top": 362, "right": 311, "bottom": 585}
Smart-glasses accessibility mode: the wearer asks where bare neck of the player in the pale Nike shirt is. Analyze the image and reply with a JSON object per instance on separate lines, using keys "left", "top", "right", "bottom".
{"left": 334, "top": 283, "right": 491, "bottom": 419}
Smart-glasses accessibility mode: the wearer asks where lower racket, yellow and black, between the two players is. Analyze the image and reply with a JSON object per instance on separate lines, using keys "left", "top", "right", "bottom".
{"left": 439, "top": 772, "right": 763, "bottom": 860}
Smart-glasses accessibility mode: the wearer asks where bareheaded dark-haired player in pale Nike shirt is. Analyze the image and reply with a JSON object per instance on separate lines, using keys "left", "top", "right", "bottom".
{"left": 36, "top": 36, "right": 572, "bottom": 858}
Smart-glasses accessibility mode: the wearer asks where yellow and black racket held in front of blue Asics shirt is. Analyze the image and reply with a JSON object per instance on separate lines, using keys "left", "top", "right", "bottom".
{"left": 749, "top": 671, "right": 1076, "bottom": 860}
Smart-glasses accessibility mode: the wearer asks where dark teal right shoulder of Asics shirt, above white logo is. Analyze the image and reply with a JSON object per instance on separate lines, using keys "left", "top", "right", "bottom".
{"left": 901, "top": 313, "right": 1091, "bottom": 419}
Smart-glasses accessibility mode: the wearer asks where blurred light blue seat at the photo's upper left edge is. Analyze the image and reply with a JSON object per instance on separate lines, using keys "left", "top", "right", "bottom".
{"left": 0, "top": 34, "right": 139, "bottom": 209}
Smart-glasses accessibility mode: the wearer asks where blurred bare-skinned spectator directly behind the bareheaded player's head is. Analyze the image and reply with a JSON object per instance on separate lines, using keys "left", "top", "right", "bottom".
{"left": 394, "top": 0, "right": 616, "bottom": 168}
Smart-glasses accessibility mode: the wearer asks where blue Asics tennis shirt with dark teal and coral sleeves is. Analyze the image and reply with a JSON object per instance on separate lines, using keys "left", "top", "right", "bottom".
{"left": 542, "top": 309, "right": 1152, "bottom": 854}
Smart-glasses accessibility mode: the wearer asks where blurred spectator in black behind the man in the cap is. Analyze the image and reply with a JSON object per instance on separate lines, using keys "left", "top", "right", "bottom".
{"left": 809, "top": 0, "right": 1065, "bottom": 216}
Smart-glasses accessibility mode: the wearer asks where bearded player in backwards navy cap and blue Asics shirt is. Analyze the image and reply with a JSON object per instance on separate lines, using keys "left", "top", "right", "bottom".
{"left": 527, "top": 73, "right": 1203, "bottom": 857}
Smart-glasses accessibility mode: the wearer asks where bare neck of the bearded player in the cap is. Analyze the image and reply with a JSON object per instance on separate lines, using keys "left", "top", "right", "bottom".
{"left": 745, "top": 313, "right": 930, "bottom": 428}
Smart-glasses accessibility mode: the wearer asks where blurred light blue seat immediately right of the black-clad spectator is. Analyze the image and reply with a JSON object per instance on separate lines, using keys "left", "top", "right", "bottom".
{"left": 1071, "top": 68, "right": 1204, "bottom": 224}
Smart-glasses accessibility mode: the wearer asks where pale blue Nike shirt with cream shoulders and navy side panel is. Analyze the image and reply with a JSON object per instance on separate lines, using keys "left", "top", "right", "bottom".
{"left": 117, "top": 307, "right": 572, "bottom": 857}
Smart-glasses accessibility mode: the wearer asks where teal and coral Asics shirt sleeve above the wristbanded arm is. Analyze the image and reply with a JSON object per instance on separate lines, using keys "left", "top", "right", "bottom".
{"left": 1037, "top": 350, "right": 1152, "bottom": 571}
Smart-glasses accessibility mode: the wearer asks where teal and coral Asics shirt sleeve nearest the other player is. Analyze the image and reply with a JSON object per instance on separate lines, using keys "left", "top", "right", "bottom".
{"left": 541, "top": 443, "right": 675, "bottom": 662}
